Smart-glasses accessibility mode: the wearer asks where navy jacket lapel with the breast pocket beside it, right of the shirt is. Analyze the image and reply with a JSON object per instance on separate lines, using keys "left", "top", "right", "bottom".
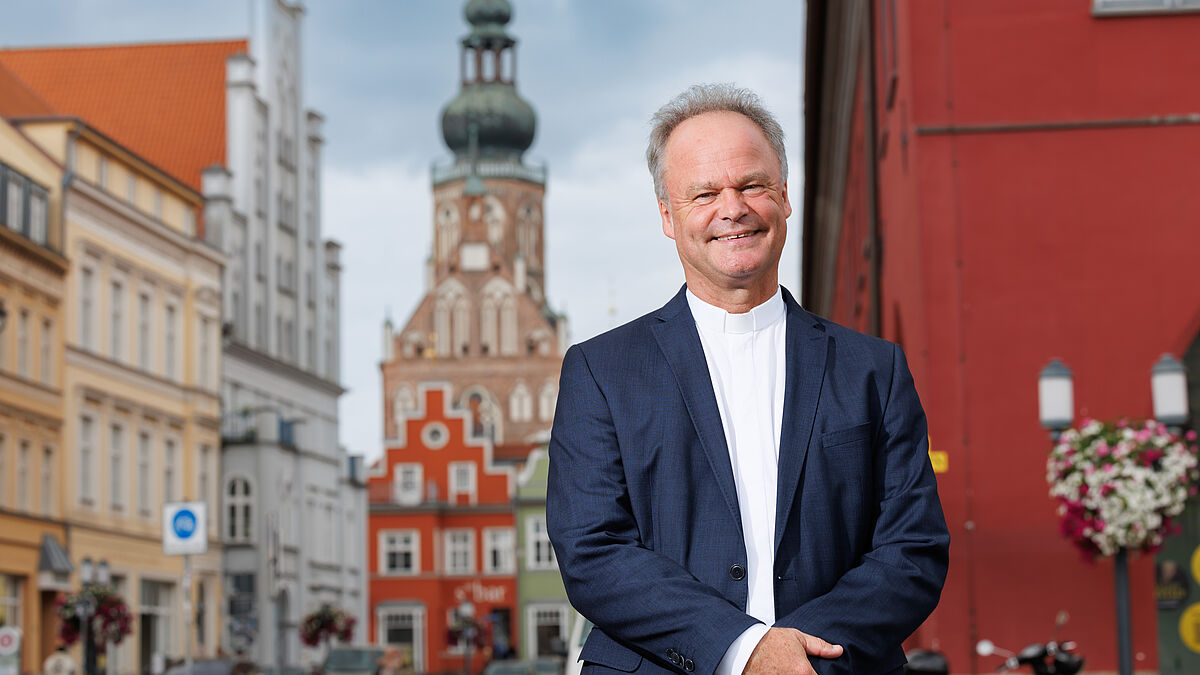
{"left": 775, "top": 289, "right": 828, "bottom": 552}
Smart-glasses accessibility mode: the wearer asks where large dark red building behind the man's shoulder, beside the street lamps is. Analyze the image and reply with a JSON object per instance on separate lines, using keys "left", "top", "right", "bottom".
{"left": 803, "top": 0, "right": 1200, "bottom": 673}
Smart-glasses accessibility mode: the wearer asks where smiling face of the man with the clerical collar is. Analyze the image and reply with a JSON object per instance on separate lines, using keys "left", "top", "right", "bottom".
{"left": 659, "top": 112, "right": 792, "bottom": 311}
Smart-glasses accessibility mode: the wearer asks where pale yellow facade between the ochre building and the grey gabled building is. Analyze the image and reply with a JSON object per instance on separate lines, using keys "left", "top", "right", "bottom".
{"left": 18, "top": 119, "right": 224, "bottom": 675}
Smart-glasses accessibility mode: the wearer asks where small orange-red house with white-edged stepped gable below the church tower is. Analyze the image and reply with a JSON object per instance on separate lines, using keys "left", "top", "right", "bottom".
{"left": 367, "top": 384, "right": 520, "bottom": 673}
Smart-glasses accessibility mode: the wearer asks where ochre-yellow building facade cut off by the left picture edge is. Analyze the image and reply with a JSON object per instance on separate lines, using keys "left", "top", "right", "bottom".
{"left": 0, "top": 111, "right": 70, "bottom": 673}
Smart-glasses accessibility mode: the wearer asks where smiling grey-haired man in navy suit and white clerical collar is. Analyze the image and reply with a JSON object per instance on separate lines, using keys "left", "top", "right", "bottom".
{"left": 546, "top": 85, "right": 949, "bottom": 675}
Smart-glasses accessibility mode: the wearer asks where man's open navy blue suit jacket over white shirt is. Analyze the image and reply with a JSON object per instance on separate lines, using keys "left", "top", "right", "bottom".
{"left": 546, "top": 289, "right": 949, "bottom": 675}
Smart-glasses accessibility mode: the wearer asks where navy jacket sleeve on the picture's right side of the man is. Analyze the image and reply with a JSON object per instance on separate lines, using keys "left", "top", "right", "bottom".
{"left": 775, "top": 346, "right": 949, "bottom": 675}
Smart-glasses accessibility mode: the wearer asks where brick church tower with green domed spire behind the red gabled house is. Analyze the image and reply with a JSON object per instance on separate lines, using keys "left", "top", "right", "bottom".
{"left": 380, "top": 0, "right": 566, "bottom": 451}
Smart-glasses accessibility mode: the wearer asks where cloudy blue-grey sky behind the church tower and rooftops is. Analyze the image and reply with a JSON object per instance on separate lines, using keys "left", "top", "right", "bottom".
{"left": 0, "top": 0, "right": 804, "bottom": 458}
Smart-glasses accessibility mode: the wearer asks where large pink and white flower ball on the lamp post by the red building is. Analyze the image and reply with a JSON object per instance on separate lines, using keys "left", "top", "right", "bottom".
{"left": 1046, "top": 419, "right": 1200, "bottom": 561}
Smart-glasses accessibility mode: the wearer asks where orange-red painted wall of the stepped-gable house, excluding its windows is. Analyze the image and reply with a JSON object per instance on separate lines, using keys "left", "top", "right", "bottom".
{"left": 367, "top": 387, "right": 520, "bottom": 673}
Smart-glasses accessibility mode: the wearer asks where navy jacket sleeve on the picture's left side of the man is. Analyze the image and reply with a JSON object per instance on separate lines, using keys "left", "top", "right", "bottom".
{"left": 546, "top": 346, "right": 756, "bottom": 675}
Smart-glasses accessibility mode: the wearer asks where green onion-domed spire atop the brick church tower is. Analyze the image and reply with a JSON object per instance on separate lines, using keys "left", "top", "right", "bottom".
{"left": 442, "top": 0, "right": 536, "bottom": 160}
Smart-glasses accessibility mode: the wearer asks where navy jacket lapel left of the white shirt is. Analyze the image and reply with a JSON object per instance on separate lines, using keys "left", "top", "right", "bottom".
{"left": 650, "top": 286, "right": 742, "bottom": 531}
